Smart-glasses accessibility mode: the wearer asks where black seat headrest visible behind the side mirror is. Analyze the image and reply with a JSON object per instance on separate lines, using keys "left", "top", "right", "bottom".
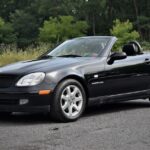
{"left": 122, "top": 44, "right": 137, "bottom": 56}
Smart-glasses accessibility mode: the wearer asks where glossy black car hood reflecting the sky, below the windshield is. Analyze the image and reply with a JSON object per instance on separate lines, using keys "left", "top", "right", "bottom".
{"left": 0, "top": 57, "right": 87, "bottom": 74}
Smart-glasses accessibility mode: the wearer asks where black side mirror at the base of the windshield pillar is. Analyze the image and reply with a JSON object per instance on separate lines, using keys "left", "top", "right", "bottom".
{"left": 108, "top": 52, "right": 127, "bottom": 64}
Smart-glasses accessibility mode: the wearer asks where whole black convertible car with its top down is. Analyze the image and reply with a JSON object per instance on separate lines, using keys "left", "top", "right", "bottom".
{"left": 0, "top": 36, "right": 150, "bottom": 122}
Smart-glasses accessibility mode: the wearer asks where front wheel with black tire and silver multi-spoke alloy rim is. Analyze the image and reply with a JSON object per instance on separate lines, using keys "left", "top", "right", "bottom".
{"left": 50, "top": 79, "right": 86, "bottom": 122}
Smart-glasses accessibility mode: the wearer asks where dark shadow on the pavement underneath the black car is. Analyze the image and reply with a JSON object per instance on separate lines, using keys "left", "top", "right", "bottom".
{"left": 0, "top": 100, "right": 150, "bottom": 126}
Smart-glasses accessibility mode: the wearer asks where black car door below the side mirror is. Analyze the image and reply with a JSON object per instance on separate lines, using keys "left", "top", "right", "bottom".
{"left": 102, "top": 55, "right": 150, "bottom": 95}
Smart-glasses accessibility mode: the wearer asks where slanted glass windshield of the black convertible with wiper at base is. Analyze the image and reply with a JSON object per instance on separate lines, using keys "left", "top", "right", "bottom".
{"left": 47, "top": 37, "right": 110, "bottom": 57}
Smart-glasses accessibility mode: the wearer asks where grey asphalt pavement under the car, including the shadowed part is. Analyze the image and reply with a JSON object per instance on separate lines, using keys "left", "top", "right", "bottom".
{"left": 0, "top": 100, "right": 150, "bottom": 150}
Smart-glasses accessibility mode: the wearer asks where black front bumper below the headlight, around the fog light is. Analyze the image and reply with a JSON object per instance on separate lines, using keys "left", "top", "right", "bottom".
{"left": 0, "top": 92, "right": 52, "bottom": 112}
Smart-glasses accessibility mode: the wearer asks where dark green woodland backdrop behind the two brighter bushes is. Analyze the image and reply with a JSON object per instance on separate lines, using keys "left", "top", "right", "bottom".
{"left": 0, "top": 0, "right": 150, "bottom": 47}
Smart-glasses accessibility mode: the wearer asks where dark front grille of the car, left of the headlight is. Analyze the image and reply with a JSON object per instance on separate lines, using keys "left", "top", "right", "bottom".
{"left": 0, "top": 74, "right": 17, "bottom": 88}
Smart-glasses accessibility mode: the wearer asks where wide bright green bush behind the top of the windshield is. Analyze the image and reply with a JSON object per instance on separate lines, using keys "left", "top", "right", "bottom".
{"left": 39, "top": 16, "right": 88, "bottom": 43}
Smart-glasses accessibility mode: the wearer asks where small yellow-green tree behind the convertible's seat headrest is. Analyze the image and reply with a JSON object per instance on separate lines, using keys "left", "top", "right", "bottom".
{"left": 110, "top": 19, "right": 140, "bottom": 49}
